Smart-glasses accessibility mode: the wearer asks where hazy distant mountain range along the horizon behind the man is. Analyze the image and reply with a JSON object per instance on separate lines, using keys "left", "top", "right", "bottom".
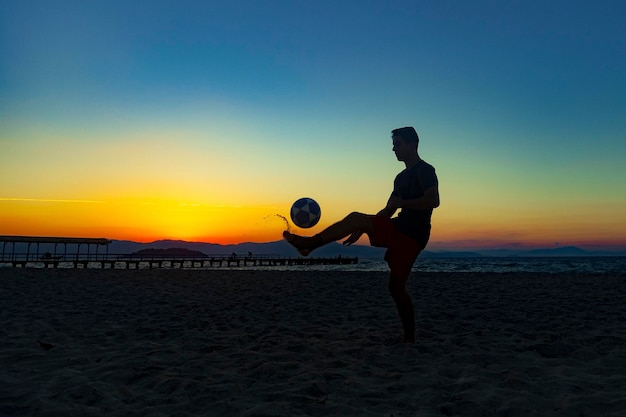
{"left": 108, "top": 240, "right": 626, "bottom": 259}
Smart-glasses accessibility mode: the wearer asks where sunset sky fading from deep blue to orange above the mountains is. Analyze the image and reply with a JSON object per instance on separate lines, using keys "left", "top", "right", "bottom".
{"left": 0, "top": 0, "right": 626, "bottom": 250}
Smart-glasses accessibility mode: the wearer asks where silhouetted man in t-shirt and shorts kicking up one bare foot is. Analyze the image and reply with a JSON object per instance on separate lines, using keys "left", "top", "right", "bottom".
{"left": 283, "top": 127, "right": 439, "bottom": 343}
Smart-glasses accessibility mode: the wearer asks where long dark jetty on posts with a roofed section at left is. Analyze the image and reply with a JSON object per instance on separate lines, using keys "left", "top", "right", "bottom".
{"left": 0, "top": 236, "right": 359, "bottom": 269}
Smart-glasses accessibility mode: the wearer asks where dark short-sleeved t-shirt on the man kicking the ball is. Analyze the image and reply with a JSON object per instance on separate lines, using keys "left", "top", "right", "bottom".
{"left": 391, "top": 161, "right": 438, "bottom": 244}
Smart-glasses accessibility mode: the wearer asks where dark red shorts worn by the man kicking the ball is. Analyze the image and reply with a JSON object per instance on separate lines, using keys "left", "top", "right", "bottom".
{"left": 369, "top": 216, "right": 426, "bottom": 282}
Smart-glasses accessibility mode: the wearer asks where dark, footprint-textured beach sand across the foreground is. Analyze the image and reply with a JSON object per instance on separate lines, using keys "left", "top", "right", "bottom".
{"left": 0, "top": 268, "right": 626, "bottom": 417}
